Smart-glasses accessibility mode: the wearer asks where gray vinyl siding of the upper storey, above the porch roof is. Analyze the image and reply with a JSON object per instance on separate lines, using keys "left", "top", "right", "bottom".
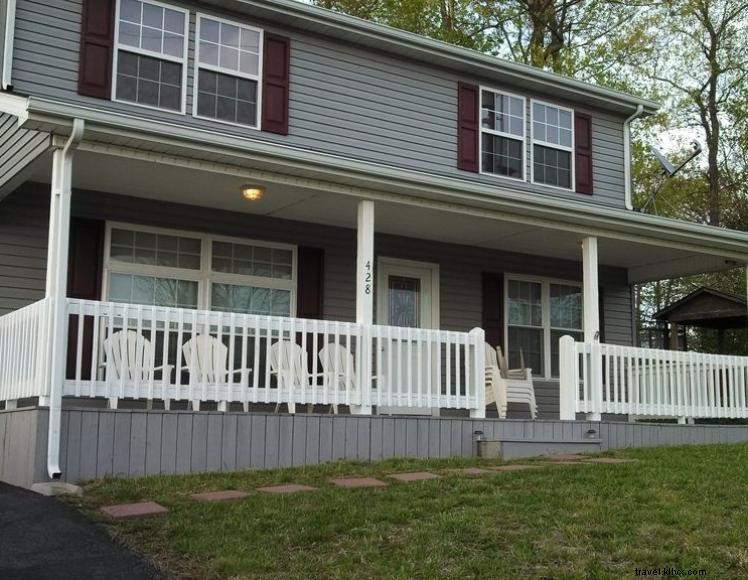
{"left": 14, "top": 0, "right": 624, "bottom": 207}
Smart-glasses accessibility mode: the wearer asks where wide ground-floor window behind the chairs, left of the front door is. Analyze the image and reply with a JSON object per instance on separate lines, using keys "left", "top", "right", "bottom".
{"left": 104, "top": 224, "right": 296, "bottom": 316}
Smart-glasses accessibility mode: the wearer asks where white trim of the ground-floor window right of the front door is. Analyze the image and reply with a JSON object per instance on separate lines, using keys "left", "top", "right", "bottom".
{"left": 503, "top": 274, "right": 584, "bottom": 381}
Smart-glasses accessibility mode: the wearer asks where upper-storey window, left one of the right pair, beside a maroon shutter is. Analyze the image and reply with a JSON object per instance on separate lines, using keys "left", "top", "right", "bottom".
{"left": 480, "top": 89, "right": 525, "bottom": 179}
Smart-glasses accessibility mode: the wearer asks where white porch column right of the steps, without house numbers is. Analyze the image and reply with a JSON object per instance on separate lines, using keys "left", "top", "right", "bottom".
{"left": 582, "top": 236, "right": 603, "bottom": 421}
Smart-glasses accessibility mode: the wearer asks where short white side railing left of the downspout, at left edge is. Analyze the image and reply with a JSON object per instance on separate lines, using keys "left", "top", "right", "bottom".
{"left": 0, "top": 299, "right": 52, "bottom": 408}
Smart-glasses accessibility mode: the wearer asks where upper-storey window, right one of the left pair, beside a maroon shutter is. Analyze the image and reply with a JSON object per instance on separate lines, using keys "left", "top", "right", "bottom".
{"left": 194, "top": 14, "right": 262, "bottom": 127}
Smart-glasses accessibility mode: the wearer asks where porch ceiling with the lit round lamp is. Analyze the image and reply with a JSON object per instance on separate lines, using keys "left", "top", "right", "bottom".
{"left": 23, "top": 150, "right": 748, "bottom": 282}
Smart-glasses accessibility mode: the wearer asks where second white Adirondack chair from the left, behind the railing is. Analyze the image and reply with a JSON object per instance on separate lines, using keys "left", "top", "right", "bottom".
{"left": 182, "top": 334, "right": 252, "bottom": 411}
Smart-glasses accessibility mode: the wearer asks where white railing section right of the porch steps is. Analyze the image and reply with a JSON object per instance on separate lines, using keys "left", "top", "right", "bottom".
{"left": 560, "top": 336, "right": 748, "bottom": 420}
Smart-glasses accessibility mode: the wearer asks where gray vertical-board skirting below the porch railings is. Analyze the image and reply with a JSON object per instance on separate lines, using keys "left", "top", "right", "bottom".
{"left": 0, "top": 408, "right": 748, "bottom": 487}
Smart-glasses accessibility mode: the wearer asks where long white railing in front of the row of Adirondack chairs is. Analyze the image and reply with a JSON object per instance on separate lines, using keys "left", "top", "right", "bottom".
{"left": 63, "top": 299, "right": 485, "bottom": 416}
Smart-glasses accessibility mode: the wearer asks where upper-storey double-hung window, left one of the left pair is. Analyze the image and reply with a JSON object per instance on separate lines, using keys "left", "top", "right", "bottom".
{"left": 112, "top": 0, "right": 189, "bottom": 113}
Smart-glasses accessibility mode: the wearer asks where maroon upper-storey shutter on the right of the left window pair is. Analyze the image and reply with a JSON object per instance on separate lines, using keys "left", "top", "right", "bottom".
{"left": 262, "top": 33, "right": 291, "bottom": 135}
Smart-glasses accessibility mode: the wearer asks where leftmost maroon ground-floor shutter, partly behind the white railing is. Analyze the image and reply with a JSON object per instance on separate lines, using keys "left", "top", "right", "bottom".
{"left": 67, "top": 218, "right": 104, "bottom": 379}
